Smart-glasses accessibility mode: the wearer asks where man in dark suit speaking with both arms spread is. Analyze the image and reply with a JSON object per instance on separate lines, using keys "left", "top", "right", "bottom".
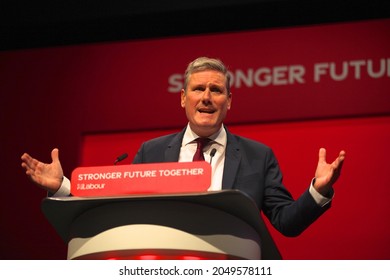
{"left": 22, "top": 57, "right": 345, "bottom": 236}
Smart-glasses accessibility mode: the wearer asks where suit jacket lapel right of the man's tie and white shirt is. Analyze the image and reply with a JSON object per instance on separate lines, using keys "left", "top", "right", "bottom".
{"left": 222, "top": 129, "right": 241, "bottom": 189}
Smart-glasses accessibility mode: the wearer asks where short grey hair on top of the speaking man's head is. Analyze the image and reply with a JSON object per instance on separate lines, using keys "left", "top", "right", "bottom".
{"left": 184, "top": 56, "right": 230, "bottom": 95}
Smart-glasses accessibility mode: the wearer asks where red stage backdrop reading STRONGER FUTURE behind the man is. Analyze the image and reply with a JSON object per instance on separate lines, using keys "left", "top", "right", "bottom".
{"left": 0, "top": 19, "right": 390, "bottom": 259}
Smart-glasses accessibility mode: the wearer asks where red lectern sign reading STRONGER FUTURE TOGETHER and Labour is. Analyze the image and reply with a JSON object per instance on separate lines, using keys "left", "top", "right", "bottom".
{"left": 71, "top": 161, "right": 211, "bottom": 197}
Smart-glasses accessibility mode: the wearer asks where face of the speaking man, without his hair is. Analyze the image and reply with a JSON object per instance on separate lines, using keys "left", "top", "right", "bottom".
{"left": 181, "top": 70, "right": 232, "bottom": 137}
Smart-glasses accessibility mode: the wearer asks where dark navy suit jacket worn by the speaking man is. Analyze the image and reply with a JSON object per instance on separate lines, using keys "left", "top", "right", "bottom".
{"left": 133, "top": 129, "right": 330, "bottom": 236}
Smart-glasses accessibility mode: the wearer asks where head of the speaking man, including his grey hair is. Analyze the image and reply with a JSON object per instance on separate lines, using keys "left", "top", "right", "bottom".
{"left": 181, "top": 57, "right": 232, "bottom": 137}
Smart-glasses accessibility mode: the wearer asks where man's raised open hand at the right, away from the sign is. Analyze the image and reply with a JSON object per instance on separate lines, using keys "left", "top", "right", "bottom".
{"left": 313, "top": 148, "right": 345, "bottom": 196}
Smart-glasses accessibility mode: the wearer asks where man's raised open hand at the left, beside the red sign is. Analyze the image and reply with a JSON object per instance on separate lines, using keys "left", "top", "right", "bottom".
{"left": 21, "top": 148, "right": 64, "bottom": 193}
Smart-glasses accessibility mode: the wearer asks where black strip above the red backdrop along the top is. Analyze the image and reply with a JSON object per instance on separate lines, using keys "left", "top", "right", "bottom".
{"left": 0, "top": 0, "right": 390, "bottom": 50}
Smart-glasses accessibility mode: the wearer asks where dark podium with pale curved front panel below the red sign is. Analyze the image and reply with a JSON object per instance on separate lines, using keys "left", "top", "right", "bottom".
{"left": 41, "top": 190, "right": 281, "bottom": 259}
